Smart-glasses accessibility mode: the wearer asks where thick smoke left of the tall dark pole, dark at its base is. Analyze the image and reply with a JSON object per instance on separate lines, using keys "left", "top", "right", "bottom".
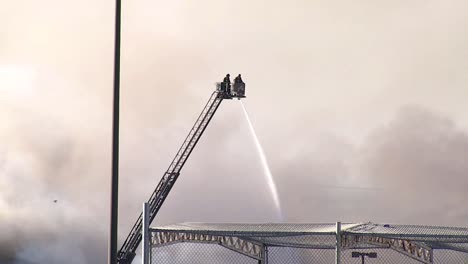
{"left": 0, "top": 87, "right": 108, "bottom": 263}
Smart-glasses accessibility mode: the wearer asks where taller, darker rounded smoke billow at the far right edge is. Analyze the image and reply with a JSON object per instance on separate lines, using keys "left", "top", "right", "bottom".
{"left": 356, "top": 107, "right": 468, "bottom": 226}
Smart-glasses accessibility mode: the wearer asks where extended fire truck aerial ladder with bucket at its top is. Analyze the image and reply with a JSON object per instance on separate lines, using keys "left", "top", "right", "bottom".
{"left": 117, "top": 77, "right": 245, "bottom": 264}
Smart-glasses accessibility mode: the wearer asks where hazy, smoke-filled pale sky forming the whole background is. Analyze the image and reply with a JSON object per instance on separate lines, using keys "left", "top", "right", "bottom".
{"left": 0, "top": 0, "right": 468, "bottom": 264}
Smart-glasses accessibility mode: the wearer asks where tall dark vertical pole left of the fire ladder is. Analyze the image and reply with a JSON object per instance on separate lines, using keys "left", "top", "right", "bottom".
{"left": 108, "top": 0, "right": 121, "bottom": 264}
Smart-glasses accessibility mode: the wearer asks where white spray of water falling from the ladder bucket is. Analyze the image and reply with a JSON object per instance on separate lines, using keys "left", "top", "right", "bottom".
{"left": 240, "top": 101, "right": 283, "bottom": 220}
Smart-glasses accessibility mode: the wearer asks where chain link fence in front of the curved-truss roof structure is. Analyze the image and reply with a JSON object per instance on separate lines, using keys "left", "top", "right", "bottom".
{"left": 149, "top": 223, "right": 468, "bottom": 264}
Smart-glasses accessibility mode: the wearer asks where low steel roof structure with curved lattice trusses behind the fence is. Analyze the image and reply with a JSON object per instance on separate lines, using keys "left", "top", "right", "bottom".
{"left": 147, "top": 222, "right": 468, "bottom": 264}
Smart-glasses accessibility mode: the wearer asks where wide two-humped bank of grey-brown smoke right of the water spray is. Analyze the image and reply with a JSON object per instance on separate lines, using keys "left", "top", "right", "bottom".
{"left": 274, "top": 106, "right": 468, "bottom": 226}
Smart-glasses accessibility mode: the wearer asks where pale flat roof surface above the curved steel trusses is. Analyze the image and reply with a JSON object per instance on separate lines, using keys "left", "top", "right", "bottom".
{"left": 151, "top": 222, "right": 468, "bottom": 253}
